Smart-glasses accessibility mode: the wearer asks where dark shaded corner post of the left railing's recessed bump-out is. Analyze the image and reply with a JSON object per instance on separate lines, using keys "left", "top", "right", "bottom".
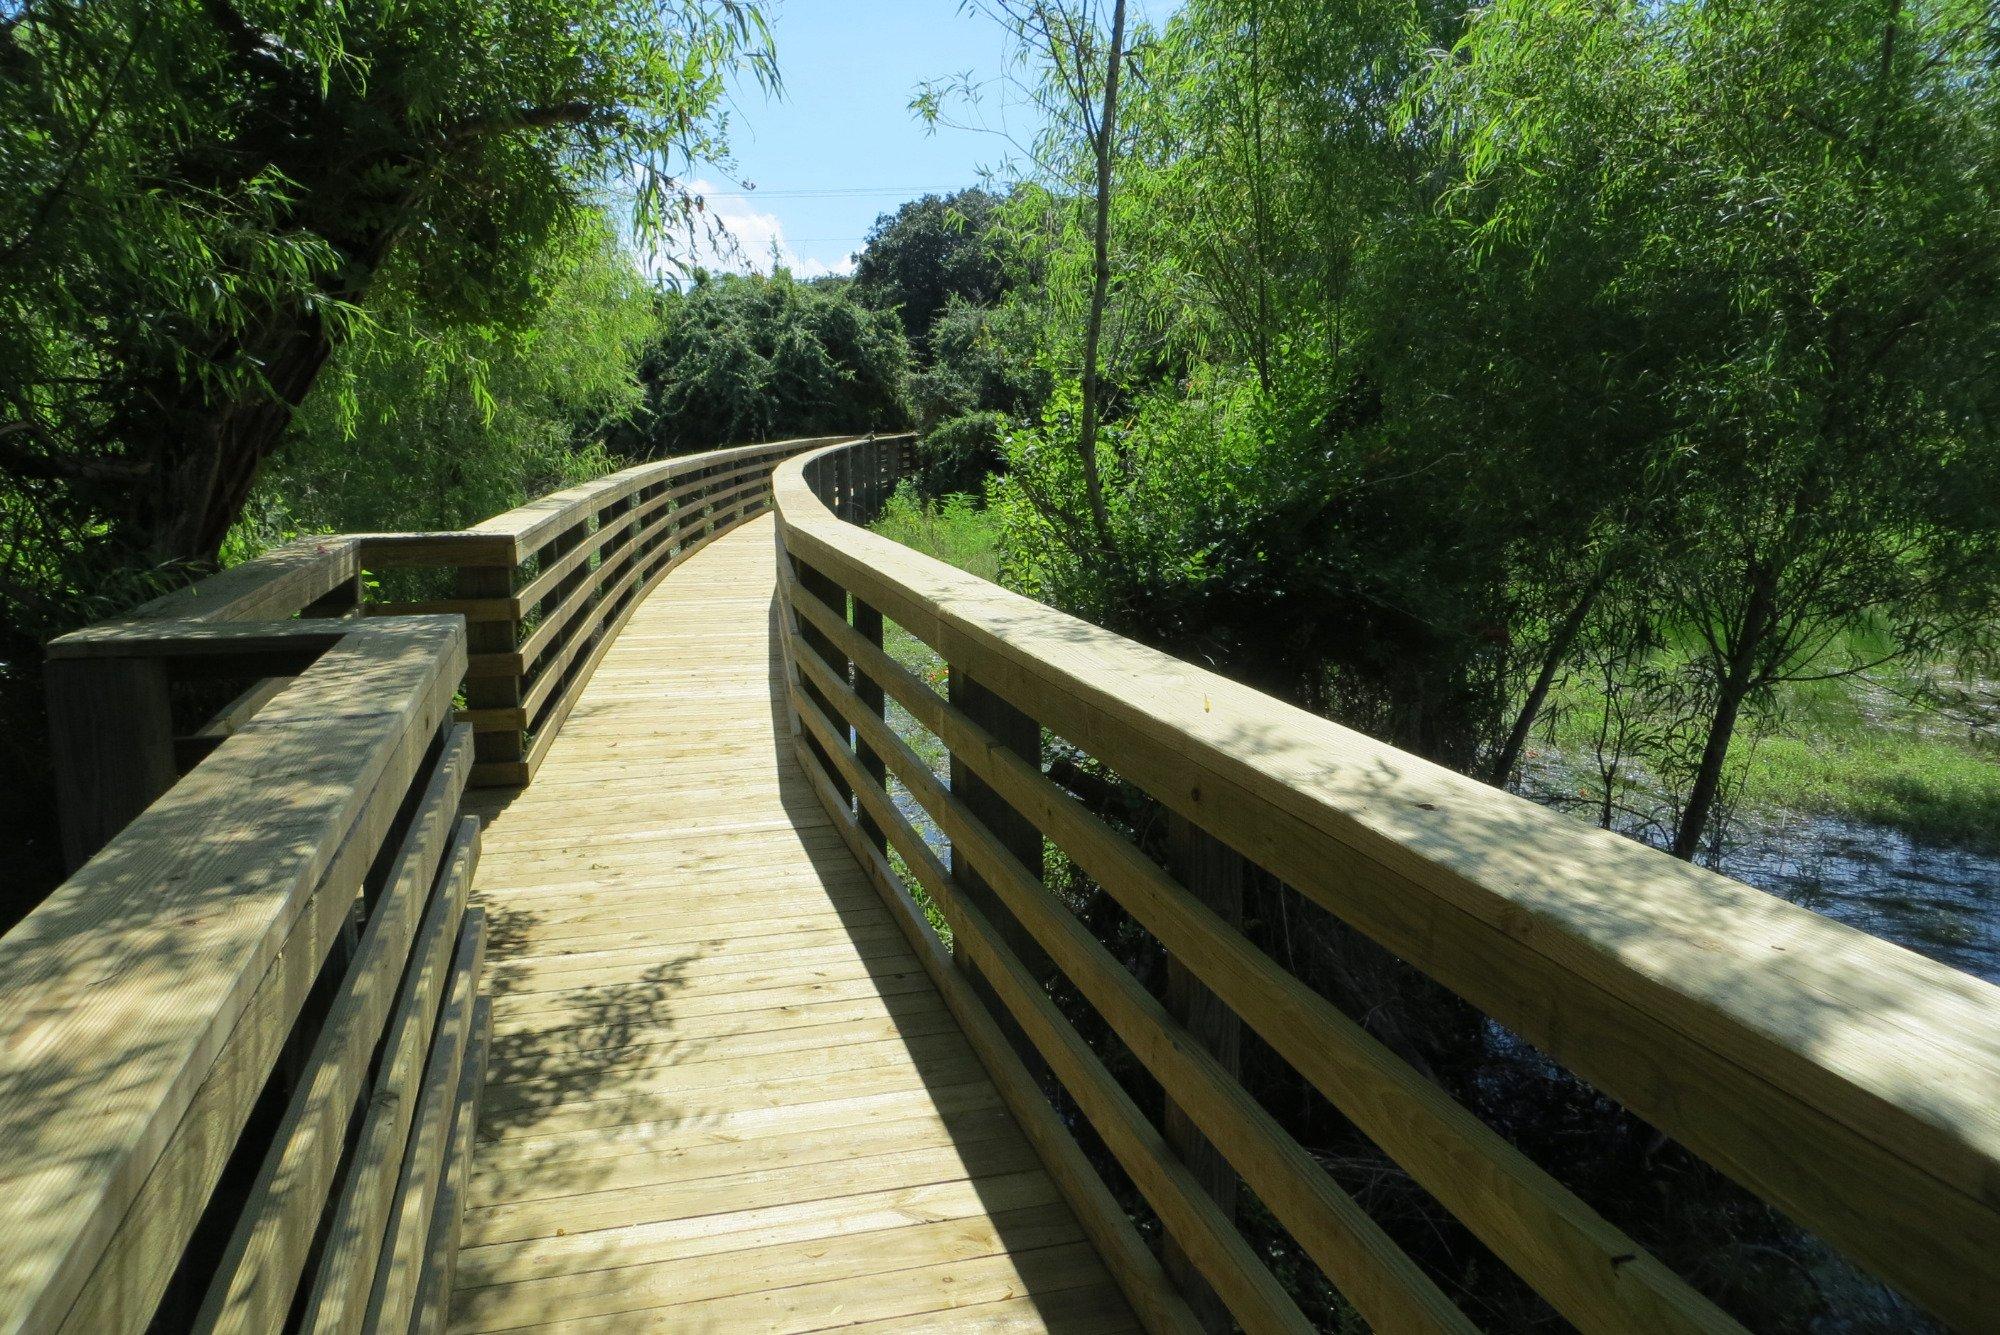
{"left": 44, "top": 658, "right": 178, "bottom": 871}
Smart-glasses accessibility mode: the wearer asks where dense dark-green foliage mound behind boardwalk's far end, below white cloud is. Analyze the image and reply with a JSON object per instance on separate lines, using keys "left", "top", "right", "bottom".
{"left": 616, "top": 272, "right": 910, "bottom": 458}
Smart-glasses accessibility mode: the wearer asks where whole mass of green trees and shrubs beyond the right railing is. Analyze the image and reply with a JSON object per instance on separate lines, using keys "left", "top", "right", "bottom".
{"left": 918, "top": 0, "right": 2000, "bottom": 857}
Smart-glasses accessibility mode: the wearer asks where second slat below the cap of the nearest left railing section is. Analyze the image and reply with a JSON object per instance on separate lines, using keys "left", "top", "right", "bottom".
{"left": 300, "top": 817, "right": 480, "bottom": 1335}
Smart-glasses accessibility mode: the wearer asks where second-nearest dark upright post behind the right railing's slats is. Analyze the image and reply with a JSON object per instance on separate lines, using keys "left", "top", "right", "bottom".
{"left": 946, "top": 664, "right": 1054, "bottom": 1081}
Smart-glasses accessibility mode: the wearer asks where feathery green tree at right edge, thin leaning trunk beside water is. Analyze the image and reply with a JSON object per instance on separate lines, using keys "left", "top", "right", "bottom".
{"left": 1430, "top": 0, "right": 2000, "bottom": 857}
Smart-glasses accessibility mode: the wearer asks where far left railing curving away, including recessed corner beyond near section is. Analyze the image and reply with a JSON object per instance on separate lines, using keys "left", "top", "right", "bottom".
{"left": 48, "top": 429, "right": 860, "bottom": 867}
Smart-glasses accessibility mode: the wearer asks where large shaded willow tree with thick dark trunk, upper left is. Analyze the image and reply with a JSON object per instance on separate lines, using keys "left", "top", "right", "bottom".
{"left": 0, "top": 0, "right": 774, "bottom": 602}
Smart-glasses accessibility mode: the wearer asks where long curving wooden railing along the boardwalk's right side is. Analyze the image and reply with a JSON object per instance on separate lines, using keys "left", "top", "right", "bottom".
{"left": 776, "top": 442, "right": 2000, "bottom": 1331}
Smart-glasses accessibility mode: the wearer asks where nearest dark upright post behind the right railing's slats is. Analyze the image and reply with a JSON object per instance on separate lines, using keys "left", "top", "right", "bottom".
{"left": 1162, "top": 811, "right": 1244, "bottom": 1333}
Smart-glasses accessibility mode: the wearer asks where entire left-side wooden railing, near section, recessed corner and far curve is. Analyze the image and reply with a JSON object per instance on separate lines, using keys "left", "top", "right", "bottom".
{"left": 0, "top": 433, "right": 868, "bottom": 1333}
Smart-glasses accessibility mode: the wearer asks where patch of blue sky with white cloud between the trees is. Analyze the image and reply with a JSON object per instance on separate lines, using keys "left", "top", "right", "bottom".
{"left": 698, "top": 0, "right": 1172, "bottom": 278}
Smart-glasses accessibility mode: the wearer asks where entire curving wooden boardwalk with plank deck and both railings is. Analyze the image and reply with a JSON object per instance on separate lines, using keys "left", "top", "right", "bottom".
{"left": 0, "top": 438, "right": 2000, "bottom": 1331}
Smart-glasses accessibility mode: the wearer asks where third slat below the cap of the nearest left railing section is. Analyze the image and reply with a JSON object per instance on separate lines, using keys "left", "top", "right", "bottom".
{"left": 362, "top": 907, "right": 486, "bottom": 1331}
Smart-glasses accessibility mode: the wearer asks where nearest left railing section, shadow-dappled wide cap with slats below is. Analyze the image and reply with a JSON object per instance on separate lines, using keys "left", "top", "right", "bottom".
{"left": 0, "top": 615, "right": 486, "bottom": 1333}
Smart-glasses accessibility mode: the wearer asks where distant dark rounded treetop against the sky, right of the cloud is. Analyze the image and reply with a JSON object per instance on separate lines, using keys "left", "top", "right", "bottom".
{"left": 854, "top": 188, "right": 1008, "bottom": 352}
